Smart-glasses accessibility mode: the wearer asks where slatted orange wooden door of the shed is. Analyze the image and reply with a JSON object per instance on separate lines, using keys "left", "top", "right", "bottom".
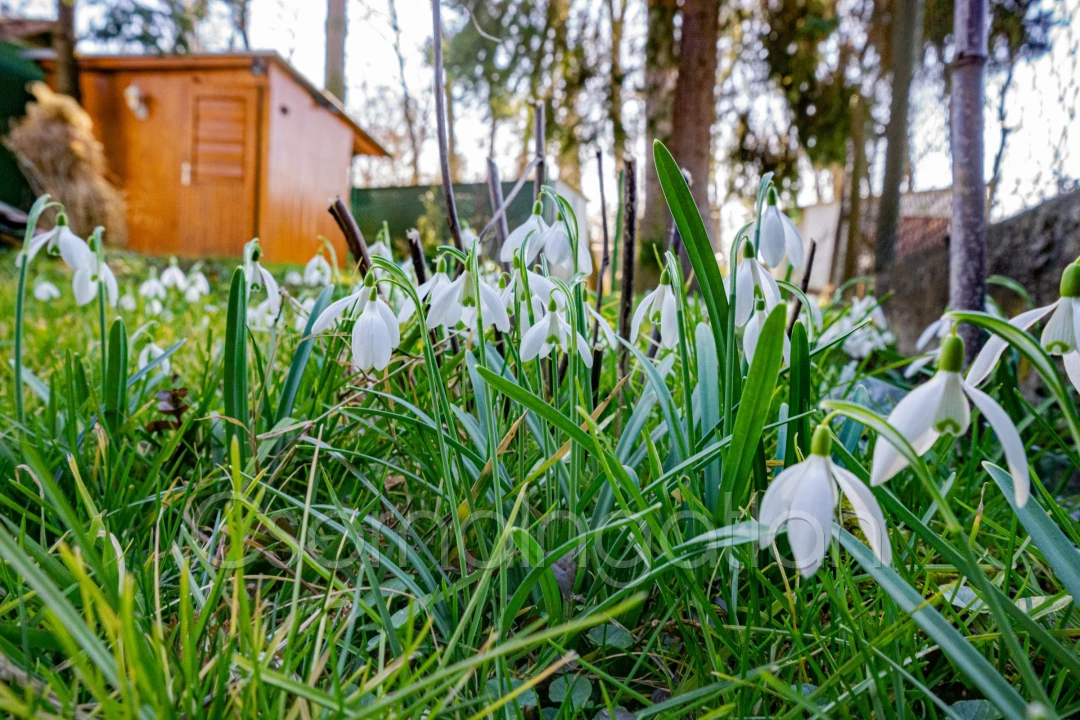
{"left": 180, "top": 84, "right": 260, "bottom": 257}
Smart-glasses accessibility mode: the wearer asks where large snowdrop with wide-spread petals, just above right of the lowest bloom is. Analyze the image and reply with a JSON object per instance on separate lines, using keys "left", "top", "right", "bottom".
{"left": 870, "top": 335, "right": 1030, "bottom": 506}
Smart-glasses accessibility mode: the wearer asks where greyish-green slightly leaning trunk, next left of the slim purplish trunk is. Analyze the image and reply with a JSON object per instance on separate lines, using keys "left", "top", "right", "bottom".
{"left": 874, "top": 0, "right": 922, "bottom": 284}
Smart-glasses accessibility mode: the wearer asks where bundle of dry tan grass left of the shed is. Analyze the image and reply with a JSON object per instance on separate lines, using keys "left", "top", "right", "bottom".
{"left": 4, "top": 82, "right": 126, "bottom": 244}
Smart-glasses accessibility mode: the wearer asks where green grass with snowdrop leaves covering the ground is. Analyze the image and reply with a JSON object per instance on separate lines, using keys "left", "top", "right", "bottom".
{"left": 0, "top": 170, "right": 1080, "bottom": 718}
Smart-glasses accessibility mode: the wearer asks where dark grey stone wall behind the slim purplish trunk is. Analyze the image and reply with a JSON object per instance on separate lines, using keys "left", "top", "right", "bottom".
{"left": 878, "top": 190, "right": 1080, "bottom": 354}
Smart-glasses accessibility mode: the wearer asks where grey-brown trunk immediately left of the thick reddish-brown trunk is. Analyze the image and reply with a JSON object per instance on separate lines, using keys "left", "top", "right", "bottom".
{"left": 639, "top": 0, "right": 678, "bottom": 253}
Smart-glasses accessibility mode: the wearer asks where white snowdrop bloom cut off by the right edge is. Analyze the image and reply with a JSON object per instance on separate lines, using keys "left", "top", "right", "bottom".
{"left": 968, "top": 262, "right": 1080, "bottom": 389}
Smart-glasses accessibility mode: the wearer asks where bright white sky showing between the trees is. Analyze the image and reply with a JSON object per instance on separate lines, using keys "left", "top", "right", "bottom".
{"left": 9, "top": 0, "right": 1080, "bottom": 250}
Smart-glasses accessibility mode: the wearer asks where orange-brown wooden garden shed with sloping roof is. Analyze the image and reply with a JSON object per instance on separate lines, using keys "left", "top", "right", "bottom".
{"left": 43, "top": 52, "right": 389, "bottom": 262}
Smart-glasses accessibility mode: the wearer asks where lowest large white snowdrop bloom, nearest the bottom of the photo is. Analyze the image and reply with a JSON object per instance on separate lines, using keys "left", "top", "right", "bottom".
{"left": 758, "top": 425, "right": 892, "bottom": 578}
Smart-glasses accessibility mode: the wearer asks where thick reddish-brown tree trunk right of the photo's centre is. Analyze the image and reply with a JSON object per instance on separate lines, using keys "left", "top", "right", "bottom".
{"left": 665, "top": 0, "right": 720, "bottom": 246}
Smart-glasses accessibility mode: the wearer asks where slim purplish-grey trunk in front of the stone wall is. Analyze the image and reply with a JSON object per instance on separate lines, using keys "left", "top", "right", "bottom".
{"left": 949, "top": 0, "right": 987, "bottom": 359}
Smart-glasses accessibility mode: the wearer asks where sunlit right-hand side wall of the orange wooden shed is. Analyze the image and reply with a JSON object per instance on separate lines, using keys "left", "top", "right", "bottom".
{"left": 259, "top": 65, "right": 353, "bottom": 263}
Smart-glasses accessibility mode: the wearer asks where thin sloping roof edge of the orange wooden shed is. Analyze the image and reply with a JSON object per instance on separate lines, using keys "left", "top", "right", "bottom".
{"left": 41, "top": 51, "right": 390, "bottom": 158}
